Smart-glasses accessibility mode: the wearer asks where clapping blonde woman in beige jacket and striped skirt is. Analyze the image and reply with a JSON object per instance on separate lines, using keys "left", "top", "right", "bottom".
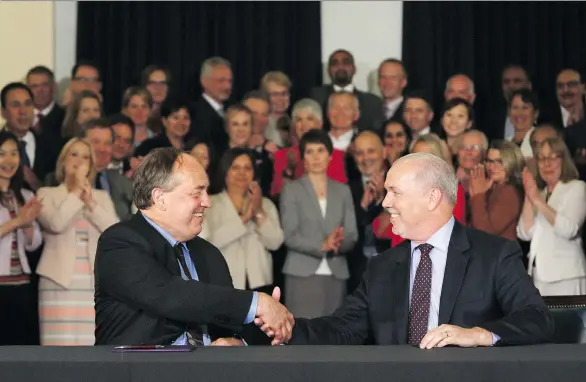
{"left": 37, "top": 138, "right": 118, "bottom": 346}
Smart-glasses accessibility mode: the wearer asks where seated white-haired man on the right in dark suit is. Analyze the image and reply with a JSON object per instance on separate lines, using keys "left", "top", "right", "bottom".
{"left": 256, "top": 153, "right": 554, "bottom": 349}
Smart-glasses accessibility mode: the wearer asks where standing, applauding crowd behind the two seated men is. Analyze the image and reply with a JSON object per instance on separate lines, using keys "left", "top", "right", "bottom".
{"left": 0, "top": 50, "right": 586, "bottom": 345}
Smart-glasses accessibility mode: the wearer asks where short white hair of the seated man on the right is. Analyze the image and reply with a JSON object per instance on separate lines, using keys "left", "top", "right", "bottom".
{"left": 393, "top": 153, "right": 458, "bottom": 206}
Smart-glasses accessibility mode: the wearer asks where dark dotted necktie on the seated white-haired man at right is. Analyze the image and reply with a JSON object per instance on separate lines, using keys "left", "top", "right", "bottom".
{"left": 409, "top": 243, "right": 433, "bottom": 345}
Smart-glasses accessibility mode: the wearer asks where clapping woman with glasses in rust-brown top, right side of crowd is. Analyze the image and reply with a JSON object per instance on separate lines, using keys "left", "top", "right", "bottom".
{"left": 468, "top": 140, "right": 525, "bottom": 240}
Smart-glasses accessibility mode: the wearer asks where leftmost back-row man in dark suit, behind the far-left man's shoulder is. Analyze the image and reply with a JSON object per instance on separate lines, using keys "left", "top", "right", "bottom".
{"left": 26, "top": 66, "right": 65, "bottom": 137}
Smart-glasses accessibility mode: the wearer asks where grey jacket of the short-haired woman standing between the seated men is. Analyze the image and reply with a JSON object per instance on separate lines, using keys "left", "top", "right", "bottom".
{"left": 280, "top": 175, "right": 358, "bottom": 280}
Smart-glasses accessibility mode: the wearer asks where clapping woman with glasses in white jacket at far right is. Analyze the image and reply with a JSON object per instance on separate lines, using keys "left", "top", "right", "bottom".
{"left": 517, "top": 138, "right": 586, "bottom": 296}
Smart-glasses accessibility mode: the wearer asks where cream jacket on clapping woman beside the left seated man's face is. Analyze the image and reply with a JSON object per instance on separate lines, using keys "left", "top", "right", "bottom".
{"left": 199, "top": 192, "right": 283, "bottom": 289}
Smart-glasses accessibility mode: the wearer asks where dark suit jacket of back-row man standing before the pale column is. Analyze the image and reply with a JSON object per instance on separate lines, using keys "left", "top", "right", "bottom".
{"left": 310, "top": 85, "right": 385, "bottom": 132}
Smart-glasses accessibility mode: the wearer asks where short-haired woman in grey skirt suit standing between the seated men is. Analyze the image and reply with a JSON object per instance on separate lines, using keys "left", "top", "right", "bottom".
{"left": 280, "top": 130, "right": 358, "bottom": 317}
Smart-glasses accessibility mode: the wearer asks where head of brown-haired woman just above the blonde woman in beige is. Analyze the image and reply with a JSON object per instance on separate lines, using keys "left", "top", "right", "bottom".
{"left": 61, "top": 90, "right": 103, "bottom": 141}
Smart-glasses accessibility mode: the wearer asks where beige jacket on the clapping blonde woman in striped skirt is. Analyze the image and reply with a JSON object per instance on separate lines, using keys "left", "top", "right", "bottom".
{"left": 37, "top": 184, "right": 118, "bottom": 288}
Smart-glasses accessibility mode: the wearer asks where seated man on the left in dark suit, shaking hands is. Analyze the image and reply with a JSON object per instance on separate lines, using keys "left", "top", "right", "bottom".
{"left": 95, "top": 148, "right": 294, "bottom": 346}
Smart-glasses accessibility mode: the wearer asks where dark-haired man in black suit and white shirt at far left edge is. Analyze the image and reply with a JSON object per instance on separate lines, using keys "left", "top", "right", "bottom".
{"left": 1, "top": 82, "right": 61, "bottom": 191}
